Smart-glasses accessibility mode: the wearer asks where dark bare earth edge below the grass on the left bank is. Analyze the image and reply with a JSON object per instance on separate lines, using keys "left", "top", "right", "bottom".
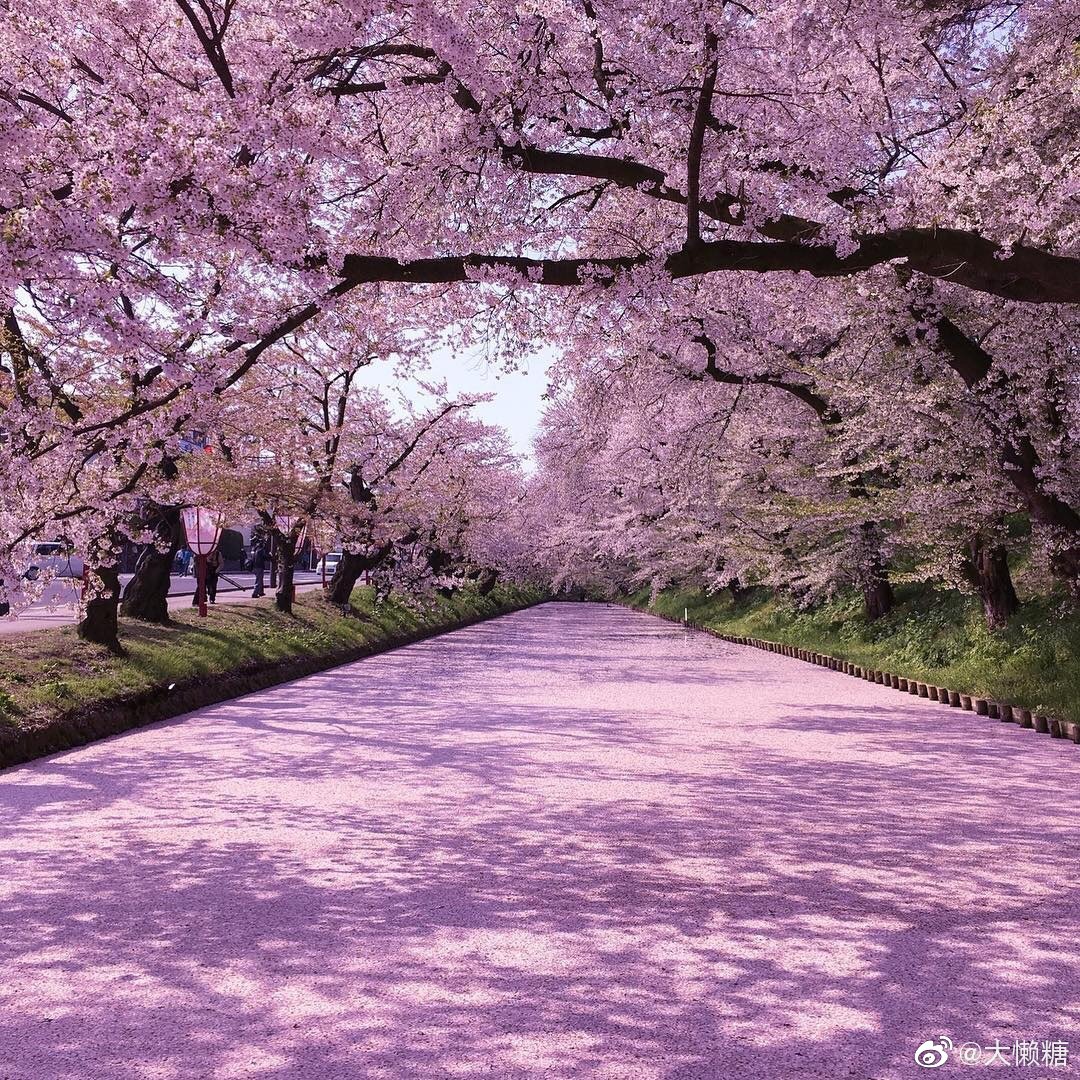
{"left": 0, "top": 598, "right": 543, "bottom": 770}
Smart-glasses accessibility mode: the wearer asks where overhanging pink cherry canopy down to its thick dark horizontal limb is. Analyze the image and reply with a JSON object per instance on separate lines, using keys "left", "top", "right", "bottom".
{"left": 0, "top": 0, "right": 1080, "bottom": 412}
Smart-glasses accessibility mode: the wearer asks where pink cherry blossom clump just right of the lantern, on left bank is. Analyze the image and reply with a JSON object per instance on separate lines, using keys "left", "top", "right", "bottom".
{"left": 172, "top": 313, "right": 519, "bottom": 611}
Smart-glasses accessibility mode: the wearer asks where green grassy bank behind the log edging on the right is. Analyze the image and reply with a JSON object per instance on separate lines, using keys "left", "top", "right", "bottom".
{"left": 629, "top": 588, "right": 1080, "bottom": 720}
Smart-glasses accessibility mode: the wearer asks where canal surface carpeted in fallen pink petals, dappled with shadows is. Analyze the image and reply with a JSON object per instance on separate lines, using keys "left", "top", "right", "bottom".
{"left": 0, "top": 604, "right": 1080, "bottom": 1080}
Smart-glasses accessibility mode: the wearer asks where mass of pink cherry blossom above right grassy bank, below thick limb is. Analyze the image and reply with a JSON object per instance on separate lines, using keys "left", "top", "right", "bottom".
{"left": 540, "top": 261, "right": 1080, "bottom": 626}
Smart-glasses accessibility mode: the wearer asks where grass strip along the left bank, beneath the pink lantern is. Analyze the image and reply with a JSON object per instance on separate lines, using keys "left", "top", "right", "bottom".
{"left": 0, "top": 585, "right": 541, "bottom": 728}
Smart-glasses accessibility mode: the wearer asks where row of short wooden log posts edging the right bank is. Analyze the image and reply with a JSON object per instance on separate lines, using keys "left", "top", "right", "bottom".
{"left": 649, "top": 611, "right": 1080, "bottom": 743}
